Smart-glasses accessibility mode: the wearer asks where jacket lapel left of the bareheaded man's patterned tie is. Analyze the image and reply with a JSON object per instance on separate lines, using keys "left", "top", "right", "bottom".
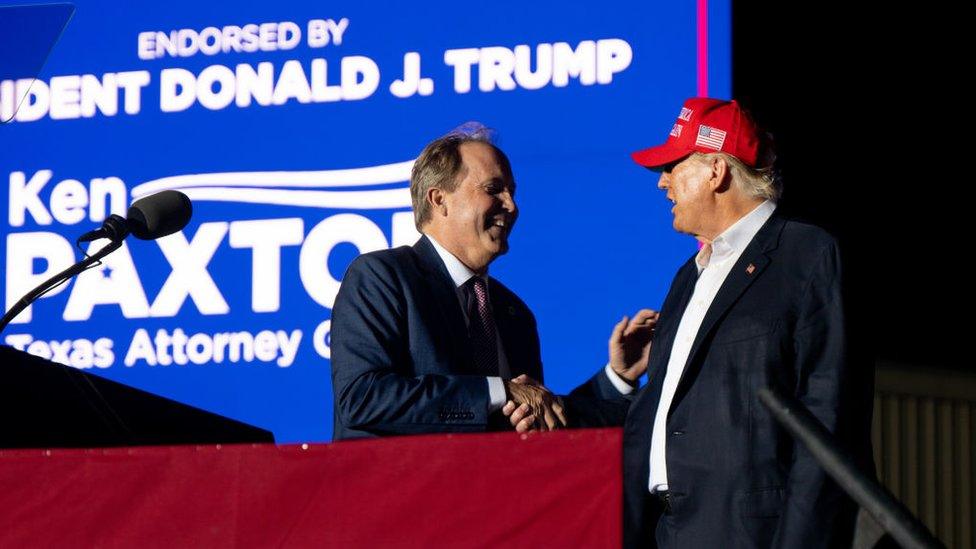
{"left": 413, "top": 235, "right": 472, "bottom": 364}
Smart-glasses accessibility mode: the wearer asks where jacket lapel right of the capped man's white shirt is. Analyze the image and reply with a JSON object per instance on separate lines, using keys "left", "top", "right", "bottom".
{"left": 671, "top": 212, "right": 784, "bottom": 404}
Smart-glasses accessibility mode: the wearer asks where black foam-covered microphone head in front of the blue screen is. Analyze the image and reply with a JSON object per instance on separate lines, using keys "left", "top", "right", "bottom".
{"left": 78, "top": 190, "right": 193, "bottom": 242}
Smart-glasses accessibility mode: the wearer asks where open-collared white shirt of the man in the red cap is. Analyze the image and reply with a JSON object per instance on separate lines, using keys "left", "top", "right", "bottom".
{"left": 647, "top": 200, "right": 776, "bottom": 492}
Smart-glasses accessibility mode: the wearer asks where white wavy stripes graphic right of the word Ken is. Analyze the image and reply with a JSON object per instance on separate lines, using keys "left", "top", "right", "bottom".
{"left": 131, "top": 160, "right": 414, "bottom": 209}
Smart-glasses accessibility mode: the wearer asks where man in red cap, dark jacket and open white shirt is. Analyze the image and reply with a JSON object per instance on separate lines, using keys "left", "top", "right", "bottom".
{"left": 624, "top": 98, "right": 853, "bottom": 548}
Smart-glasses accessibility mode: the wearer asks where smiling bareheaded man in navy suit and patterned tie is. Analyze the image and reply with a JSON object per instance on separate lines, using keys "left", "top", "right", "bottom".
{"left": 331, "top": 128, "right": 566, "bottom": 440}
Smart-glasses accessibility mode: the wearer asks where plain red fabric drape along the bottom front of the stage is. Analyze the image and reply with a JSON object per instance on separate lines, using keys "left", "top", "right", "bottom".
{"left": 0, "top": 429, "right": 622, "bottom": 549}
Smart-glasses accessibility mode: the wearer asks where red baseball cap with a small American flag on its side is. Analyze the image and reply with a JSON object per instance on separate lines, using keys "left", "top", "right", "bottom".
{"left": 630, "top": 97, "right": 759, "bottom": 169}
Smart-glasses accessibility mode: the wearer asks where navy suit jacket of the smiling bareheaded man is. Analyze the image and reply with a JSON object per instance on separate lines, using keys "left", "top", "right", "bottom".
{"left": 331, "top": 236, "right": 542, "bottom": 440}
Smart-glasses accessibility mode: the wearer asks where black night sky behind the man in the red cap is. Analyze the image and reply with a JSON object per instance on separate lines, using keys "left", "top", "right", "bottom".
{"left": 733, "top": 1, "right": 960, "bottom": 371}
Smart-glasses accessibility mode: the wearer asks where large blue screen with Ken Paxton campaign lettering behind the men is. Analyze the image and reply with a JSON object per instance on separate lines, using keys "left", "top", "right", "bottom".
{"left": 0, "top": 0, "right": 731, "bottom": 442}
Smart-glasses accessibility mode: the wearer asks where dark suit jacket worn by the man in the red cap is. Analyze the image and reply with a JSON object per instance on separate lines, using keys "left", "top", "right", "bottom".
{"left": 624, "top": 213, "right": 863, "bottom": 548}
